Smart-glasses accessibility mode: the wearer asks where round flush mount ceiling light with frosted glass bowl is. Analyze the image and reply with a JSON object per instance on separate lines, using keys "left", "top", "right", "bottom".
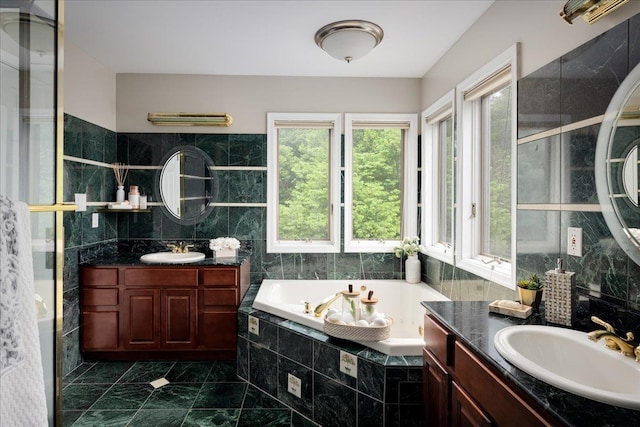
{"left": 315, "top": 19, "right": 384, "bottom": 62}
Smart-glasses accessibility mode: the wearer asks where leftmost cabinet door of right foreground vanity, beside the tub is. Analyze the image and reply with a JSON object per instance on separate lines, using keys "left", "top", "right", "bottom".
{"left": 422, "top": 349, "right": 451, "bottom": 427}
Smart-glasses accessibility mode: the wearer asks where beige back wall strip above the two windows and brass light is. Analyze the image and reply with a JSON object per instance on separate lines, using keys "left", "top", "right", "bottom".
{"left": 116, "top": 74, "right": 421, "bottom": 133}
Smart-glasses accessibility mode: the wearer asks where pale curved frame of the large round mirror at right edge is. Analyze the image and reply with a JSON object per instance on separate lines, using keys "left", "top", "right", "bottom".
{"left": 595, "top": 64, "right": 640, "bottom": 265}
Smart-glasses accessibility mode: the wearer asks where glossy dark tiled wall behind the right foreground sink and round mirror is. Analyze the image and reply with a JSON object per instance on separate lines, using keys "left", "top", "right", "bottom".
{"left": 517, "top": 15, "right": 640, "bottom": 311}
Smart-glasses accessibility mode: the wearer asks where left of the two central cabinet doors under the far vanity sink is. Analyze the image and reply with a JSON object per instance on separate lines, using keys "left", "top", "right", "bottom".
{"left": 121, "top": 289, "right": 160, "bottom": 350}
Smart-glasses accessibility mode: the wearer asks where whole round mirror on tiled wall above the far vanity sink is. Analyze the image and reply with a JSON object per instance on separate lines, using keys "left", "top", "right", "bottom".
{"left": 156, "top": 146, "right": 218, "bottom": 224}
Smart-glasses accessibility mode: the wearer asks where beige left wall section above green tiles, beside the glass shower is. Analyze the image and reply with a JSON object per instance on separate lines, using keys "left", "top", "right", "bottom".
{"left": 63, "top": 41, "right": 116, "bottom": 131}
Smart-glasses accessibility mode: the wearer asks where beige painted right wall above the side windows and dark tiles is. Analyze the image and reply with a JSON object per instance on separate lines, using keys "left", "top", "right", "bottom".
{"left": 422, "top": 0, "right": 640, "bottom": 109}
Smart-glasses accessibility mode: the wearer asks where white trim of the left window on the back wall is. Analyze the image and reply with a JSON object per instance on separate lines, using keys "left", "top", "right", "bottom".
{"left": 267, "top": 113, "right": 342, "bottom": 253}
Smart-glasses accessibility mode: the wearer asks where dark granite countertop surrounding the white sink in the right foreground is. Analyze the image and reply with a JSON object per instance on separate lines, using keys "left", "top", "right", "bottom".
{"left": 422, "top": 301, "right": 640, "bottom": 427}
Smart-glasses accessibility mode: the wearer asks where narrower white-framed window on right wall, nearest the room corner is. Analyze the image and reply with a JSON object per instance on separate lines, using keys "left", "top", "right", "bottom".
{"left": 422, "top": 90, "right": 455, "bottom": 264}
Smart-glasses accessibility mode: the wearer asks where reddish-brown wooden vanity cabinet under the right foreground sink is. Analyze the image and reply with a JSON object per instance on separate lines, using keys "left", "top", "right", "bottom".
{"left": 423, "top": 314, "right": 556, "bottom": 427}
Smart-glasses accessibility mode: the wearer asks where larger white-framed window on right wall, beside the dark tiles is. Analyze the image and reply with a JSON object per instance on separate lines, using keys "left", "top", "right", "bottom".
{"left": 456, "top": 46, "right": 517, "bottom": 289}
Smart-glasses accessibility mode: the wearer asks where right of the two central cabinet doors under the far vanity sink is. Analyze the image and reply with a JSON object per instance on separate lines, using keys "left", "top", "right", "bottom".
{"left": 161, "top": 289, "right": 198, "bottom": 348}
